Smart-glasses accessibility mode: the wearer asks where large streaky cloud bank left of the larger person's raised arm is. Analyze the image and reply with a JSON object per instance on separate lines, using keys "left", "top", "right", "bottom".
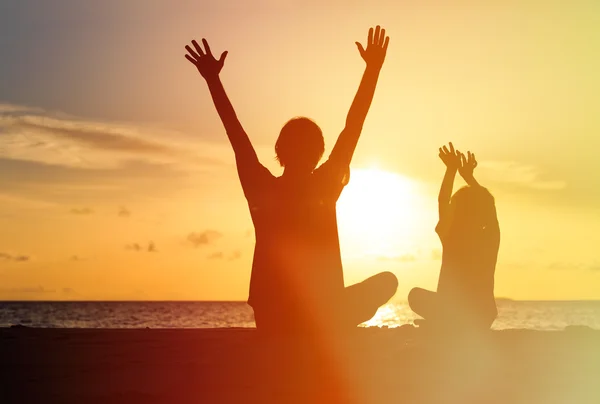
{"left": 0, "top": 104, "right": 231, "bottom": 168}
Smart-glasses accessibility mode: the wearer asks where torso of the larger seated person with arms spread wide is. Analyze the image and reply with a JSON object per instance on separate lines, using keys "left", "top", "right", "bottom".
{"left": 248, "top": 172, "right": 344, "bottom": 308}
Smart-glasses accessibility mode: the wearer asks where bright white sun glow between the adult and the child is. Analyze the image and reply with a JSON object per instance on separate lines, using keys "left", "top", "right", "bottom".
{"left": 338, "top": 169, "right": 422, "bottom": 258}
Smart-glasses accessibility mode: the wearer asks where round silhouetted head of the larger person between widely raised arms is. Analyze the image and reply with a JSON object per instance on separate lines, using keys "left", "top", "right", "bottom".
{"left": 275, "top": 117, "right": 325, "bottom": 172}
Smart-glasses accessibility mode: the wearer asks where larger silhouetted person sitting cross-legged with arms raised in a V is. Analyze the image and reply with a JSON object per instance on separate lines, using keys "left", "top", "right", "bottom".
{"left": 186, "top": 26, "right": 397, "bottom": 332}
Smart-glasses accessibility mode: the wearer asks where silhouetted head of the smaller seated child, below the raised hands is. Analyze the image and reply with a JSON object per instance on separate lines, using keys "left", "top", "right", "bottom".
{"left": 450, "top": 186, "right": 498, "bottom": 234}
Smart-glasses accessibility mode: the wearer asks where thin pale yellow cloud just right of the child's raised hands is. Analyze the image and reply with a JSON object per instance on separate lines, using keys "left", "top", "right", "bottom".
{"left": 479, "top": 161, "right": 567, "bottom": 191}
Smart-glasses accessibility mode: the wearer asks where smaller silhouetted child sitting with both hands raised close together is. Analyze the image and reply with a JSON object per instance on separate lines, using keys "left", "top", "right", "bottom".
{"left": 408, "top": 143, "right": 500, "bottom": 330}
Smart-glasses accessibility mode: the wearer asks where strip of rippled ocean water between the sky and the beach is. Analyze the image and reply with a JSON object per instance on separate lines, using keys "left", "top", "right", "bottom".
{"left": 0, "top": 300, "right": 600, "bottom": 330}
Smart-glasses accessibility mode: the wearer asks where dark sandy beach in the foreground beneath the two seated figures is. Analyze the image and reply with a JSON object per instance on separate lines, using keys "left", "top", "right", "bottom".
{"left": 0, "top": 327, "right": 600, "bottom": 404}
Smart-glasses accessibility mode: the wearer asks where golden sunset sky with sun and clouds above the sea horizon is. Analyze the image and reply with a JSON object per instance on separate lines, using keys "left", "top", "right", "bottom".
{"left": 0, "top": 0, "right": 600, "bottom": 300}
